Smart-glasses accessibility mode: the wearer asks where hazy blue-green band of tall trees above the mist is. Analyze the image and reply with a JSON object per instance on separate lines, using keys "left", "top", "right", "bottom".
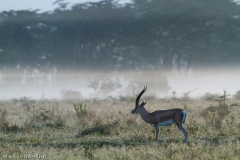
{"left": 0, "top": 0, "right": 240, "bottom": 72}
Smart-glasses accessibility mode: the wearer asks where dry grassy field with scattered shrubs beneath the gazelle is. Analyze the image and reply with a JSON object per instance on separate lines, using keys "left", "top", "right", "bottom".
{"left": 0, "top": 96, "right": 240, "bottom": 160}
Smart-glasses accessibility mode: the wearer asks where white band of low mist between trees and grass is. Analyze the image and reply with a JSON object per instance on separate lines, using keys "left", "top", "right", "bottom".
{"left": 0, "top": 68, "right": 240, "bottom": 100}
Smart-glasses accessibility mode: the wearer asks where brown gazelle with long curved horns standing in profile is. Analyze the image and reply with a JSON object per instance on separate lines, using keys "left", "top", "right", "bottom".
{"left": 131, "top": 86, "right": 188, "bottom": 143}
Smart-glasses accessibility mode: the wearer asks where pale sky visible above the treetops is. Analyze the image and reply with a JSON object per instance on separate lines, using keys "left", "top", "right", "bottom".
{"left": 0, "top": 0, "right": 130, "bottom": 12}
